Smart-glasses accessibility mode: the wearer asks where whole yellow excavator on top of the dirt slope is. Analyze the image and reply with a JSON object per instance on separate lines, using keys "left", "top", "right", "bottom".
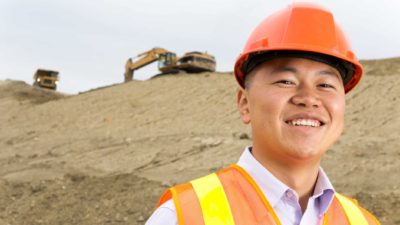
{"left": 124, "top": 48, "right": 216, "bottom": 82}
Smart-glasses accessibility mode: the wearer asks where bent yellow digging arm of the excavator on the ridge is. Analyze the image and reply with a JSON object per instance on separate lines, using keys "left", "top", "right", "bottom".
{"left": 124, "top": 48, "right": 174, "bottom": 82}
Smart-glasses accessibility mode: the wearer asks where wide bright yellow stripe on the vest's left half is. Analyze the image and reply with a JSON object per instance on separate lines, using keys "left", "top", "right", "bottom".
{"left": 190, "top": 173, "right": 235, "bottom": 225}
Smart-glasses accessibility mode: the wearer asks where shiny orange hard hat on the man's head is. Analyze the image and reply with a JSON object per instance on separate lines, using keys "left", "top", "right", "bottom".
{"left": 235, "top": 2, "right": 362, "bottom": 93}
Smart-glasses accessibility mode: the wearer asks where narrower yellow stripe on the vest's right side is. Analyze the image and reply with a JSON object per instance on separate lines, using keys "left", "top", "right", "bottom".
{"left": 335, "top": 193, "right": 368, "bottom": 225}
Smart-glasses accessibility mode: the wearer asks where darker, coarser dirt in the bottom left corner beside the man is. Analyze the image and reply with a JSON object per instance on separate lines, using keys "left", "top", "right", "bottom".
{"left": 0, "top": 174, "right": 166, "bottom": 225}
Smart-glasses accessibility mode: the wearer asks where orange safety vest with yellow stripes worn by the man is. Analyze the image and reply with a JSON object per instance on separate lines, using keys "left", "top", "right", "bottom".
{"left": 158, "top": 165, "right": 380, "bottom": 225}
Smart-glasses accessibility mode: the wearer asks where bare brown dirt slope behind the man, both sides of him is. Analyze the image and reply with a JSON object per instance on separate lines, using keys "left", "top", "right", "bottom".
{"left": 0, "top": 59, "right": 400, "bottom": 225}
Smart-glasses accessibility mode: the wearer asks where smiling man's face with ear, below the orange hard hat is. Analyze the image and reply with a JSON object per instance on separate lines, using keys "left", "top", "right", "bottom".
{"left": 238, "top": 58, "right": 345, "bottom": 162}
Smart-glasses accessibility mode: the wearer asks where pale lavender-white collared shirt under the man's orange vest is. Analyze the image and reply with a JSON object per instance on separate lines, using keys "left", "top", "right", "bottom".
{"left": 146, "top": 147, "right": 334, "bottom": 225}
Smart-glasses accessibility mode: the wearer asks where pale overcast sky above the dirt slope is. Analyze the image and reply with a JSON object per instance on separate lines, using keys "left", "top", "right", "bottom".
{"left": 0, "top": 0, "right": 400, "bottom": 93}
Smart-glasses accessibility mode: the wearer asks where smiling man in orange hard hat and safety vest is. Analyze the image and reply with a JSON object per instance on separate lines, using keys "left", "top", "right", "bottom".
{"left": 146, "top": 3, "right": 379, "bottom": 225}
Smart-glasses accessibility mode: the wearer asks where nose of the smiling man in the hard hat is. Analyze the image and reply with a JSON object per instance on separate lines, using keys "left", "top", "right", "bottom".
{"left": 292, "top": 85, "right": 321, "bottom": 108}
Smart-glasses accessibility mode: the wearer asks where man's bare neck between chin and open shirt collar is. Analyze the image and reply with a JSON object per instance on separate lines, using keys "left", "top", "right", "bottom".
{"left": 252, "top": 148, "right": 320, "bottom": 213}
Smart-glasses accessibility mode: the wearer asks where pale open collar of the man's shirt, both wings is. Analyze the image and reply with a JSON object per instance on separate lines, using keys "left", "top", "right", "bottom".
{"left": 237, "top": 147, "right": 334, "bottom": 215}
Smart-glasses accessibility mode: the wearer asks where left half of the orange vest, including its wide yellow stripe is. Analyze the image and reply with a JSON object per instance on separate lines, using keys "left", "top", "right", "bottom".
{"left": 158, "top": 166, "right": 280, "bottom": 225}
